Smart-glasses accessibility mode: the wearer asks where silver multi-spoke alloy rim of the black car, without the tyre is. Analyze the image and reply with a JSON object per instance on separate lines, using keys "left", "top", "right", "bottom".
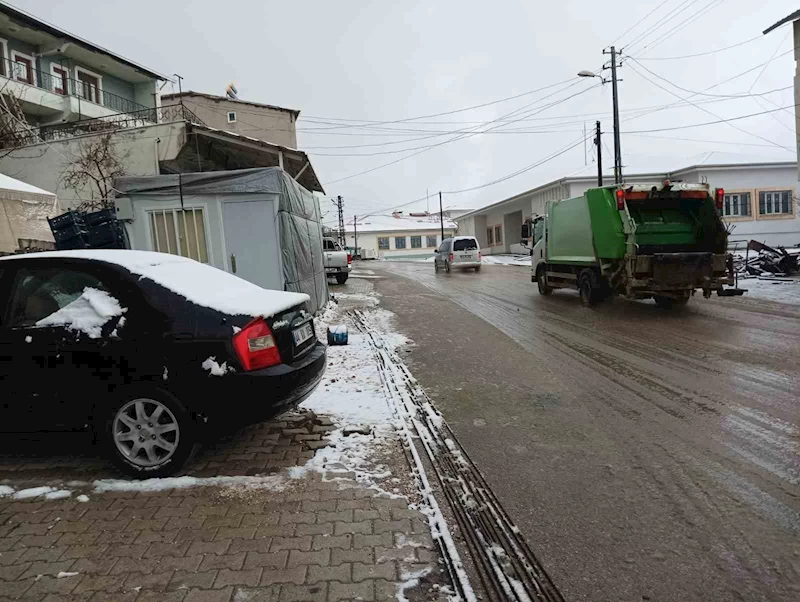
{"left": 112, "top": 398, "right": 181, "bottom": 468}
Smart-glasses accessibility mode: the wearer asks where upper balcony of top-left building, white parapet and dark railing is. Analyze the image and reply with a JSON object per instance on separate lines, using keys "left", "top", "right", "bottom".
{"left": 0, "top": 59, "right": 150, "bottom": 124}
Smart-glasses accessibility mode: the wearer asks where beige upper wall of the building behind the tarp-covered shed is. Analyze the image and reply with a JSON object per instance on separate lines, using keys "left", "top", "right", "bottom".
{"left": 161, "top": 96, "right": 297, "bottom": 148}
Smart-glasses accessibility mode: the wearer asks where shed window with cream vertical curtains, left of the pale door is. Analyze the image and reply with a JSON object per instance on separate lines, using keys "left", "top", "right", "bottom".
{"left": 148, "top": 207, "right": 208, "bottom": 263}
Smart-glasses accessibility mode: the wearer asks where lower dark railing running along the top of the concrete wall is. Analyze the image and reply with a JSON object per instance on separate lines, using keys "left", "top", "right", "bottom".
{"left": 0, "top": 105, "right": 205, "bottom": 148}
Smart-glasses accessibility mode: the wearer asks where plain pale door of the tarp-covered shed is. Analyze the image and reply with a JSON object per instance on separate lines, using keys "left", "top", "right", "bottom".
{"left": 222, "top": 201, "right": 283, "bottom": 290}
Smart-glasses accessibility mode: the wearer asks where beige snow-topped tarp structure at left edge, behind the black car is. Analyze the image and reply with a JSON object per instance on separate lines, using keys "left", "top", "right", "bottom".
{"left": 0, "top": 174, "right": 61, "bottom": 254}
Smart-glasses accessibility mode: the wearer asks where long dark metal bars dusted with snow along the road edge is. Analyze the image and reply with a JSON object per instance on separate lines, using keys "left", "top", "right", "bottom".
{"left": 352, "top": 310, "right": 564, "bottom": 602}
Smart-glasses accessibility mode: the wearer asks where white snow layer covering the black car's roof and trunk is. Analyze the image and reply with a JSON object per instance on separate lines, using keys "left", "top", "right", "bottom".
{"left": 0, "top": 249, "right": 310, "bottom": 318}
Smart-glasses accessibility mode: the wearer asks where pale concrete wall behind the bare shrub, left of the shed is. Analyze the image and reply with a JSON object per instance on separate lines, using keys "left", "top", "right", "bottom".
{"left": 0, "top": 122, "right": 186, "bottom": 210}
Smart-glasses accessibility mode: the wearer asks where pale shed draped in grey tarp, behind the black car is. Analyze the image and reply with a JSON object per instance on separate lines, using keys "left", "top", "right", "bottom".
{"left": 114, "top": 167, "right": 328, "bottom": 312}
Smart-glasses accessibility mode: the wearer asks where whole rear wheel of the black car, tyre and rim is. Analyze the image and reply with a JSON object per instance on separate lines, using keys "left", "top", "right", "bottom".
{"left": 102, "top": 388, "right": 199, "bottom": 479}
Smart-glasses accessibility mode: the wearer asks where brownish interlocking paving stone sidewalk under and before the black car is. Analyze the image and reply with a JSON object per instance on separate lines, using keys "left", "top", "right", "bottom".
{"left": 0, "top": 281, "right": 446, "bottom": 602}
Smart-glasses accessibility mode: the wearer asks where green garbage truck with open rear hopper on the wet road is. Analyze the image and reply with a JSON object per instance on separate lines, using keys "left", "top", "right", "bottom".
{"left": 523, "top": 180, "right": 741, "bottom": 308}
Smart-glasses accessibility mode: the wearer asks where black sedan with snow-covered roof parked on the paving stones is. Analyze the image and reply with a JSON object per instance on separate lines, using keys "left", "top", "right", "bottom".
{"left": 0, "top": 250, "right": 326, "bottom": 477}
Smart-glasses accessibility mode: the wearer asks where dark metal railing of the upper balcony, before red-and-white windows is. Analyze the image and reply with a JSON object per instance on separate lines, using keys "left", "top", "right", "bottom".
{"left": 0, "top": 59, "right": 148, "bottom": 113}
